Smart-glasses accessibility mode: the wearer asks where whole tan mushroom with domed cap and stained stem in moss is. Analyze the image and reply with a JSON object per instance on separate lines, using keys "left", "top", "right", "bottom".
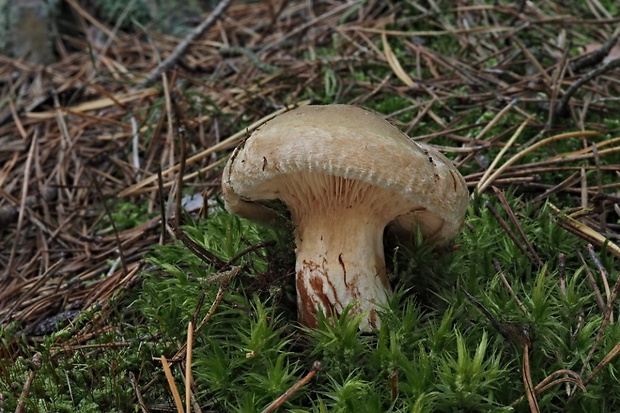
{"left": 222, "top": 105, "right": 468, "bottom": 330}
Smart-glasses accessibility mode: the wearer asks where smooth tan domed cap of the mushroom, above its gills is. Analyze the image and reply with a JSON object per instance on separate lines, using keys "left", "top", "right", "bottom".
{"left": 222, "top": 105, "right": 469, "bottom": 241}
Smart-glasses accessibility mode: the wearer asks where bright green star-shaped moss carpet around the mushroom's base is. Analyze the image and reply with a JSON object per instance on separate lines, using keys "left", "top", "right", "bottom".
{"left": 0, "top": 188, "right": 620, "bottom": 412}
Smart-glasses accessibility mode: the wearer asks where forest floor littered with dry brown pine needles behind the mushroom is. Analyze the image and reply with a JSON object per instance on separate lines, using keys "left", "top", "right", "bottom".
{"left": 0, "top": 0, "right": 620, "bottom": 411}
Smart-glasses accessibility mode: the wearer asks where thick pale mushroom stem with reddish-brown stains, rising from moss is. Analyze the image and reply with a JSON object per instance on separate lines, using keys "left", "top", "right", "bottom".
{"left": 296, "top": 207, "right": 391, "bottom": 330}
